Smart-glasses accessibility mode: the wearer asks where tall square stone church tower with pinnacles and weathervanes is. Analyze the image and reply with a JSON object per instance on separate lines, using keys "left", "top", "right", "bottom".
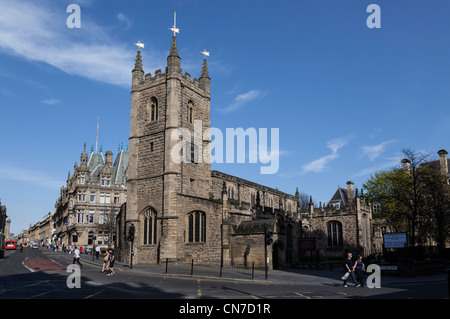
{"left": 126, "top": 15, "right": 211, "bottom": 262}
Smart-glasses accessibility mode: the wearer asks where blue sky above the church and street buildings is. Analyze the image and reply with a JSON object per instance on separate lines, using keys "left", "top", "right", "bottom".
{"left": 0, "top": 0, "right": 450, "bottom": 234}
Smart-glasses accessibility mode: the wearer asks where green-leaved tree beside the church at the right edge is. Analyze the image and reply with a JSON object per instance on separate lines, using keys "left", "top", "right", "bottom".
{"left": 363, "top": 149, "right": 450, "bottom": 258}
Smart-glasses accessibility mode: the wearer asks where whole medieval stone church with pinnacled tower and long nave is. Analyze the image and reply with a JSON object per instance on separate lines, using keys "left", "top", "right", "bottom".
{"left": 116, "top": 29, "right": 371, "bottom": 267}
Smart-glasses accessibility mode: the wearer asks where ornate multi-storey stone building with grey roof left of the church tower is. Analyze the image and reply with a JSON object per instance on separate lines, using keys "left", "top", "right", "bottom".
{"left": 52, "top": 144, "right": 128, "bottom": 252}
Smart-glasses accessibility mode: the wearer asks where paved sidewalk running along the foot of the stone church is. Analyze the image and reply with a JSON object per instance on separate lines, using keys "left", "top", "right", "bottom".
{"left": 55, "top": 252, "right": 449, "bottom": 286}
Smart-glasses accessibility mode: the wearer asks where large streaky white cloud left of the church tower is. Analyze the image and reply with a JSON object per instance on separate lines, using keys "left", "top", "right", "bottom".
{"left": 0, "top": 0, "right": 164, "bottom": 87}
